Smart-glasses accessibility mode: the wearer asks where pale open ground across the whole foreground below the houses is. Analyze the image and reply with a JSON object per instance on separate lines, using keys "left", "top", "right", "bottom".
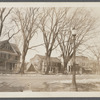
{"left": 0, "top": 74, "right": 100, "bottom": 92}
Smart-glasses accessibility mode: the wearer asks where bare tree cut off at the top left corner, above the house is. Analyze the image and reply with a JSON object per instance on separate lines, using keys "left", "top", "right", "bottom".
{"left": 0, "top": 8, "right": 13, "bottom": 36}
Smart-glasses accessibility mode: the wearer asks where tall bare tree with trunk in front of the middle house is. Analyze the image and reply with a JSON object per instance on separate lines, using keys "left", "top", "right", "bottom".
{"left": 40, "top": 8, "right": 68, "bottom": 74}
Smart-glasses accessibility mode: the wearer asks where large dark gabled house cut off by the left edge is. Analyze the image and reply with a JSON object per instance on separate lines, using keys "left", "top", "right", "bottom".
{"left": 0, "top": 40, "right": 21, "bottom": 73}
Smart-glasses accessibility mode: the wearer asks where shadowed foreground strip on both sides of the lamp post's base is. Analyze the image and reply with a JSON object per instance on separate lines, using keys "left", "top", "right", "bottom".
{"left": 33, "top": 82, "right": 100, "bottom": 92}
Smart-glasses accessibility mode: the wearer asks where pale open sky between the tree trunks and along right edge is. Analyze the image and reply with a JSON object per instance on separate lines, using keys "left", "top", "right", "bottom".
{"left": 26, "top": 8, "right": 100, "bottom": 61}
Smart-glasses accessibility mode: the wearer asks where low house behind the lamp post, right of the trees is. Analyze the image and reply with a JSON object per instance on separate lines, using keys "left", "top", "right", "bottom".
{"left": 67, "top": 56, "right": 95, "bottom": 74}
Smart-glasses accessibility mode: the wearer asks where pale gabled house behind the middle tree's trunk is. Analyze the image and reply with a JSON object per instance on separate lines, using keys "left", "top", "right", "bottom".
{"left": 26, "top": 54, "right": 61, "bottom": 73}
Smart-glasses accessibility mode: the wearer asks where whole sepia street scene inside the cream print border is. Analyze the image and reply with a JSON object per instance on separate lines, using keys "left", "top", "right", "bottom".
{"left": 0, "top": 4, "right": 100, "bottom": 92}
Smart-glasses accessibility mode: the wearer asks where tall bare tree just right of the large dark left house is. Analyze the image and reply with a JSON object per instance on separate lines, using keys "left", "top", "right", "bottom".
{"left": 13, "top": 8, "right": 39, "bottom": 74}
